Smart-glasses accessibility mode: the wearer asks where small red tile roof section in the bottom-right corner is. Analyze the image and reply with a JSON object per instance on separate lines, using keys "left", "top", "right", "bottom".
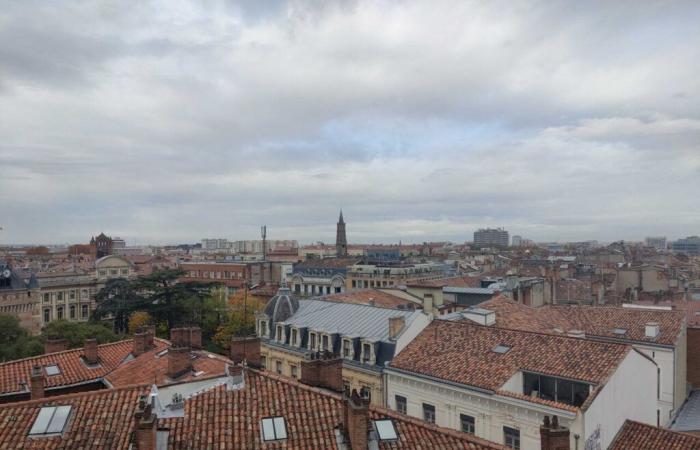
{"left": 608, "top": 420, "right": 700, "bottom": 450}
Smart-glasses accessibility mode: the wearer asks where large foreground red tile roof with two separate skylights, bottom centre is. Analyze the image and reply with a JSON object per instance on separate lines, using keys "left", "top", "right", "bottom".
{"left": 163, "top": 370, "right": 503, "bottom": 450}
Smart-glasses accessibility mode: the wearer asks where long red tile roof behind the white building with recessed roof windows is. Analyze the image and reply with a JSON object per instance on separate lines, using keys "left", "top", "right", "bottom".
{"left": 476, "top": 296, "right": 684, "bottom": 345}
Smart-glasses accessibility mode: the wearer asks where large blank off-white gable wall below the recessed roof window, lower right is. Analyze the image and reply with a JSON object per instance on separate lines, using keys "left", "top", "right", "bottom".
{"left": 584, "top": 350, "right": 657, "bottom": 448}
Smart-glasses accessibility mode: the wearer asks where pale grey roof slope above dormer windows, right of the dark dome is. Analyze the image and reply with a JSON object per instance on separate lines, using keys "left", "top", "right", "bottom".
{"left": 284, "top": 300, "right": 422, "bottom": 341}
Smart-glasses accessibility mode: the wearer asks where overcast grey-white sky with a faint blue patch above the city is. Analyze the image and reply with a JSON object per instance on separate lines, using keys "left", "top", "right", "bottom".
{"left": 0, "top": 0, "right": 700, "bottom": 244}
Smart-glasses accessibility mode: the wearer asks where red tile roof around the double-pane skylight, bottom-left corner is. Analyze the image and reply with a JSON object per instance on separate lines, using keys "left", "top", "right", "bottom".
{"left": 0, "top": 386, "right": 148, "bottom": 450}
